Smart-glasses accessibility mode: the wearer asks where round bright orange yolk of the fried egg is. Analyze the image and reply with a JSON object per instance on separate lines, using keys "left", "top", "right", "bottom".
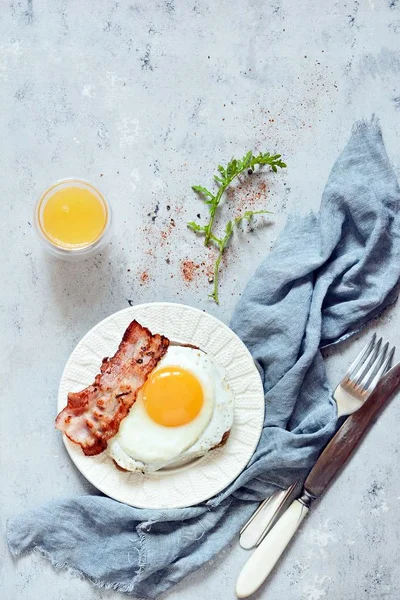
{"left": 143, "top": 367, "right": 204, "bottom": 427}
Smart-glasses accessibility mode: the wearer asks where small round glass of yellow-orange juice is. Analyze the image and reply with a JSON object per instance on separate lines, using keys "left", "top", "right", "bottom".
{"left": 35, "top": 179, "right": 111, "bottom": 260}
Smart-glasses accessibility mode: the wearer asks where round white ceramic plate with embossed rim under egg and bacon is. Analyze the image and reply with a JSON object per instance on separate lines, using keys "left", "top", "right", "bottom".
{"left": 58, "top": 302, "right": 264, "bottom": 508}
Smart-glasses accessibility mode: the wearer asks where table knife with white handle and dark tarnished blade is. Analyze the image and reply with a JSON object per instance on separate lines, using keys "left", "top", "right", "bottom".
{"left": 236, "top": 363, "right": 400, "bottom": 598}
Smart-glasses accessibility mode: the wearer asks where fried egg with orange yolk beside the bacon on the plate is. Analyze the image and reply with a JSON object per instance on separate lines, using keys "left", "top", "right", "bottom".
{"left": 108, "top": 346, "right": 234, "bottom": 472}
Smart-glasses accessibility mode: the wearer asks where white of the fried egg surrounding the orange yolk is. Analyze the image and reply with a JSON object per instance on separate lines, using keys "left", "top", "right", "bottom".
{"left": 108, "top": 346, "right": 234, "bottom": 472}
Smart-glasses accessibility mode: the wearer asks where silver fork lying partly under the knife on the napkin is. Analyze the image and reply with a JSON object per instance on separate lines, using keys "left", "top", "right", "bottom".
{"left": 239, "top": 333, "right": 395, "bottom": 550}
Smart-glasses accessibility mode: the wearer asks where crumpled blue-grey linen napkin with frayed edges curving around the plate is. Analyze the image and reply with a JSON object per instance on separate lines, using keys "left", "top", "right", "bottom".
{"left": 8, "top": 120, "right": 400, "bottom": 598}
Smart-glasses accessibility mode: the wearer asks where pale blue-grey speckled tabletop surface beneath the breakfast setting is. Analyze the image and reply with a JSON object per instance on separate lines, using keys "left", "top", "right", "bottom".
{"left": 0, "top": 0, "right": 400, "bottom": 600}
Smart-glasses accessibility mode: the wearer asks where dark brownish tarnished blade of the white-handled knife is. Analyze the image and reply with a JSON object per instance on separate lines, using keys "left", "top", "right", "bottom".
{"left": 304, "top": 363, "right": 400, "bottom": 498}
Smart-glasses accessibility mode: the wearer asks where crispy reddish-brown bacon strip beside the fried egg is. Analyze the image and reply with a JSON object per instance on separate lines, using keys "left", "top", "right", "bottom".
{"left": 56, "top": 321, "right": 169, "bottom": 456}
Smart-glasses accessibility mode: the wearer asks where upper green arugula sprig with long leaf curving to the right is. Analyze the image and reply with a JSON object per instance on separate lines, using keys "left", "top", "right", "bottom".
{"left": 188, "top": 150, "right": 286, "bottom": 246}
